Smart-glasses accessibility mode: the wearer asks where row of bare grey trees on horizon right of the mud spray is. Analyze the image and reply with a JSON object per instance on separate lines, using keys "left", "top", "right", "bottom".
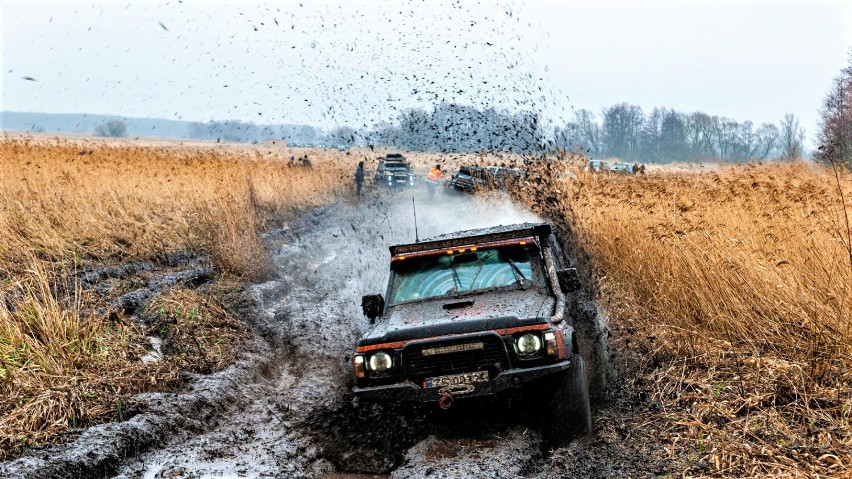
{"left": 555, "top": 103, "right": 805, "bottom": 163}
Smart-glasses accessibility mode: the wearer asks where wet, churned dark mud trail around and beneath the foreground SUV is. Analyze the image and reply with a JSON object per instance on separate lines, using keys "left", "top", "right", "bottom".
{"left": 0, "top": 193, "right": 667, "bottom": 479}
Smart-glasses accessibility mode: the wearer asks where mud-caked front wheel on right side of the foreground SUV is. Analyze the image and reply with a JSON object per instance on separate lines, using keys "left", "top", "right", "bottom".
{"left": 542, "top": 354, "right": 592, "bottom": 447}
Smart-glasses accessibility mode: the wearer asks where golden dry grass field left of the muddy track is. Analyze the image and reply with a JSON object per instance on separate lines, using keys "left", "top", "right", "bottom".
{"left": 0, "top": 137, "right": 351, "bottom": 460}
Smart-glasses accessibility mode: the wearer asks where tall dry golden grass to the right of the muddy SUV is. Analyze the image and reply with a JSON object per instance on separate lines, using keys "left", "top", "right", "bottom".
{"left": 522, "top": 160, "right": 852, "bottom": 477}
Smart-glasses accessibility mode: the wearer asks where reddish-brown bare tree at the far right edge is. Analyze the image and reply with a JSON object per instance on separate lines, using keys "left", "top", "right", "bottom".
{"left": 814, "top": 53, "right": 852, "bottom": 167}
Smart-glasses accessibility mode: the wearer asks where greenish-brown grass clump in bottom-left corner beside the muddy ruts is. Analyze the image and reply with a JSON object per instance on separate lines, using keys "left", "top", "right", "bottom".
{"left": 0, "top": 260, "right": 179, "bottom": 460}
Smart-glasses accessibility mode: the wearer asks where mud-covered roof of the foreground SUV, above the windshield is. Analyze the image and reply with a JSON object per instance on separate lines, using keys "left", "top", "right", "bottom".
{"left": 390, "top": 223, "right": 551, "bottom": 256}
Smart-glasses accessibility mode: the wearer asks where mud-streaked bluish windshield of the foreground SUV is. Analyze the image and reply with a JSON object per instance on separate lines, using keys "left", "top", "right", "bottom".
{"left": 390, "top": 245, "right": 542, "bottom": 304}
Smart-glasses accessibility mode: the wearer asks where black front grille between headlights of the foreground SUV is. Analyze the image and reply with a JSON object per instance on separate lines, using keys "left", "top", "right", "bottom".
{"left": 402, "top": 334, "right": 508, "bottom": 384}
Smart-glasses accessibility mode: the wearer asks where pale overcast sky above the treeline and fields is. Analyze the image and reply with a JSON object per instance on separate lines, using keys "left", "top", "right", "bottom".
{"left": 0, "top": 0, "right": 852, "bottom": 147}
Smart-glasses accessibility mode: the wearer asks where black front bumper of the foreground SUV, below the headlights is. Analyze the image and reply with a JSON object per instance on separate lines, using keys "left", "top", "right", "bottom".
{"left": 352, "top": 359, "right": 571, "bottom": 402}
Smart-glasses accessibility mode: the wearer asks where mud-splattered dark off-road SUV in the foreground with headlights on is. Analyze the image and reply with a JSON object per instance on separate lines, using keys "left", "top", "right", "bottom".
{"left": 352, "top": 224, "right": 591, "bottom": 443}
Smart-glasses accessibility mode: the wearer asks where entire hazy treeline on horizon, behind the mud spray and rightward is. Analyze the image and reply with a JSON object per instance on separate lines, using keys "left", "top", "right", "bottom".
{"left": 352, "top": 102, "right": 804, "bottom": 163}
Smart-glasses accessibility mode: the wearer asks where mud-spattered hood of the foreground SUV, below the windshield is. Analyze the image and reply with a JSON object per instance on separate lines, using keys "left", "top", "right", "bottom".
{"left": 358, "top": 287, "right": 556, "bottom": 346}
